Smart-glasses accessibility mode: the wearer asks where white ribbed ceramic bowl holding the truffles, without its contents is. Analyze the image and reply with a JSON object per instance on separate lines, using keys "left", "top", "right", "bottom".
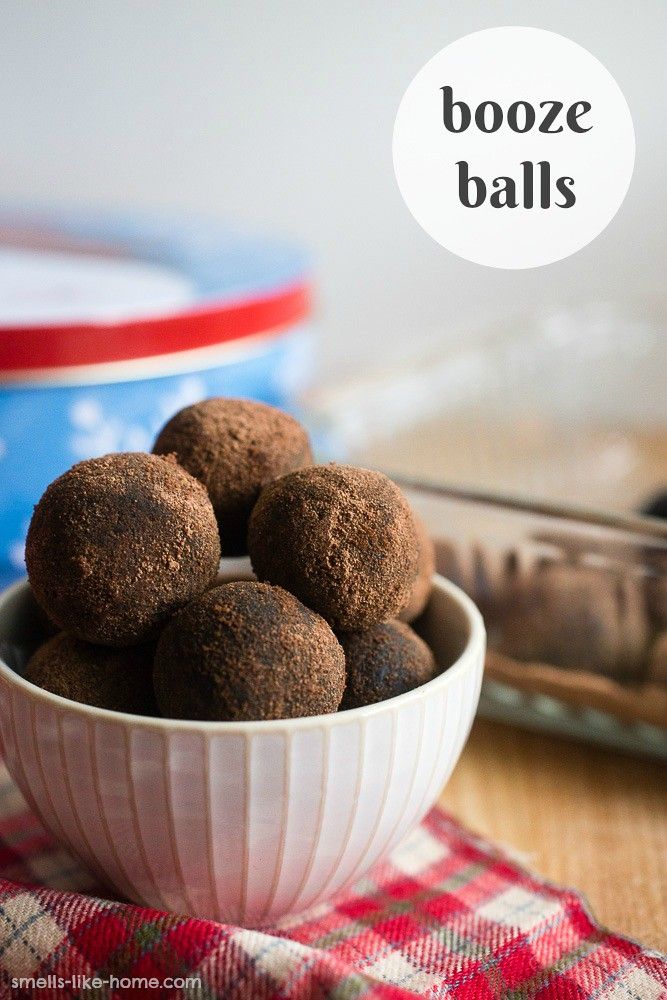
{"left": 0, "top": 577, "right": 485, "bottom": 926}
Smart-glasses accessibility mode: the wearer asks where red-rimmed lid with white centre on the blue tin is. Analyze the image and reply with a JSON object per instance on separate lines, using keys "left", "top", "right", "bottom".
{"left": 0, "top": 211, "right": 310, "bottom": 378}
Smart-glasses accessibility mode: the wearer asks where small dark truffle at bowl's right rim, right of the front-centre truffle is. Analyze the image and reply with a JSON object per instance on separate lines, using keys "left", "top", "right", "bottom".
{"left": 340, "top": 621, "right": 436, "bottom": 709}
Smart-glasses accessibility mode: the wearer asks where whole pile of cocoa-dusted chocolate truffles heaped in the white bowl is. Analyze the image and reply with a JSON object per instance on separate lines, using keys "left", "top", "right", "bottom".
{"left": 26, "top": 399, "right": 435, "bottom": 721}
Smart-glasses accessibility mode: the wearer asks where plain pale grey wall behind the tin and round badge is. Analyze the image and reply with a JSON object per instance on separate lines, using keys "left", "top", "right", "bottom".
{"left": 0, "top": 0, "right": 667, "bottom": 374}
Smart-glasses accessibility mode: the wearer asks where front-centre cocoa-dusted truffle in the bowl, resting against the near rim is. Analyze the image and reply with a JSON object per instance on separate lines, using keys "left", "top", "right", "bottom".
{"left": 153, "top": 581, "right": 345, "bottom": 721}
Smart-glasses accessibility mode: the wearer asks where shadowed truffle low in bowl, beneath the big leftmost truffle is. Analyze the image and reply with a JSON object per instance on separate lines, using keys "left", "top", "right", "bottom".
{"left": 25, "top": 632, "right": 156, "bottom": 715}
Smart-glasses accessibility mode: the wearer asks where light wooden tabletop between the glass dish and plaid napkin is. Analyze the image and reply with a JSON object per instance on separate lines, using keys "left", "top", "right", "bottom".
{"left": 440, "top": 719, "right": 667, "bottom": 950}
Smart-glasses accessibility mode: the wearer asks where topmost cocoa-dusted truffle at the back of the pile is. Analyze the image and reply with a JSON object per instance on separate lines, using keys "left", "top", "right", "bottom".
{"left": 153, "top": 399, "right": 313, "bottom": 556}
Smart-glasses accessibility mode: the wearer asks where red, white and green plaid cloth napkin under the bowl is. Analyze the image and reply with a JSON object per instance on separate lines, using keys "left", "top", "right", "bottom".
{"left": 0, "top": 765, "right": 667, "bottom": 1000}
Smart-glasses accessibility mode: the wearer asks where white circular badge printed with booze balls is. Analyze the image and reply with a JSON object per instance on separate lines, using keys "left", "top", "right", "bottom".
{"left": 393, "top": 27, "right": 635, "bottom": 268}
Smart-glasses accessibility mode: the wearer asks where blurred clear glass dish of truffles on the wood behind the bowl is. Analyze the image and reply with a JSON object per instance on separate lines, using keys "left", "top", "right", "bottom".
{"left": 396, "top": 477, "right": 667, "bottom": 757}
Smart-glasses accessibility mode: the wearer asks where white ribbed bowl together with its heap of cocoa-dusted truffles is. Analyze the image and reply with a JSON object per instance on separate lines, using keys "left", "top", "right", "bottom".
{"left": 0, "top": 399, "right": 485, "bottom": 926}
